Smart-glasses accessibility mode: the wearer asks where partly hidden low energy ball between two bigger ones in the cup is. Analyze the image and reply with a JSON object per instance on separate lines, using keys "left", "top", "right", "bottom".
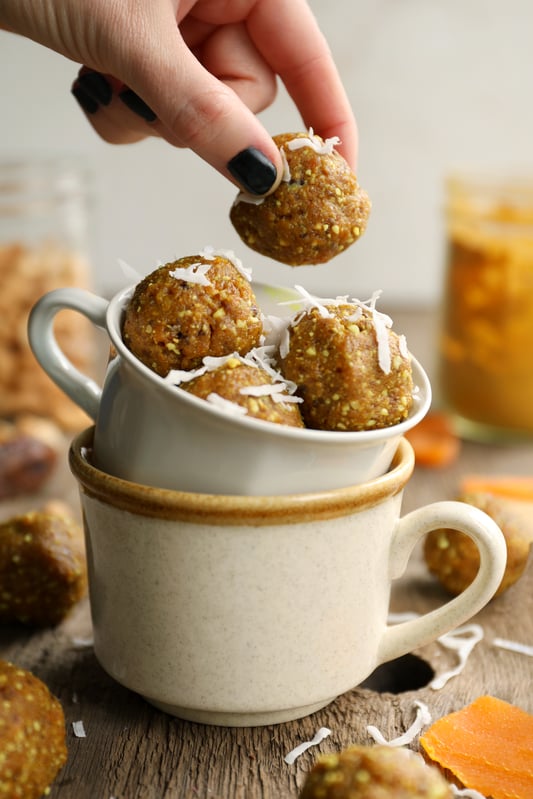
{"left": 181, "top": 357, "right": 304, "bottom": 427}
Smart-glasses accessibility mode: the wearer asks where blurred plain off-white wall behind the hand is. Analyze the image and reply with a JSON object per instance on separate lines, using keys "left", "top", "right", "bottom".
{"left": 0, "top": 0, "right": 533, "bottom": 305}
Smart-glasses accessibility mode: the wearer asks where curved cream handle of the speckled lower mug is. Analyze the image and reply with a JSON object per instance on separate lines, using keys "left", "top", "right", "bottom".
{"left": 378, "top": 501, "right": 507, "bottom": 663}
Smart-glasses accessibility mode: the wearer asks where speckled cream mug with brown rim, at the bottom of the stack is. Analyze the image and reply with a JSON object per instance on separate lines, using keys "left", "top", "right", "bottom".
{"left": 69, "top": 430, "right": 506, "bottom": 726}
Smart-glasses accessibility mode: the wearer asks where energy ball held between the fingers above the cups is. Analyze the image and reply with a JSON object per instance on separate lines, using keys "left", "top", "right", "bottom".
{"left": 230, "top": 131, "right": 371, "bottom": 266}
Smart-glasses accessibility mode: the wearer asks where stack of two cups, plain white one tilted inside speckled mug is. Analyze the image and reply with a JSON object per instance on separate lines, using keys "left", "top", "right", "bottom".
{"left": 29, "top": 289, "right": 505, "bottom": 726}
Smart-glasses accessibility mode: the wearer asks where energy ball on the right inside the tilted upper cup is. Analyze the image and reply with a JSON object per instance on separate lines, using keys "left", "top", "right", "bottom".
{"left": 280, "top": 303, "right": 413, "bottom": 432}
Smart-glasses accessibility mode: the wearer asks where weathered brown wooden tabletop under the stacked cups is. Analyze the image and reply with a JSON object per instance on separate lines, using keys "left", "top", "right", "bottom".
{"left": 0, "top": 311, "right": 533, "bottom": 799}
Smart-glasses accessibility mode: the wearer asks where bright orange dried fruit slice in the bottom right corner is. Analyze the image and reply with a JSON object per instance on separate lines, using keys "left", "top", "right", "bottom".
{"left": 420, "top": 696, "right": 533, "bottom": 799}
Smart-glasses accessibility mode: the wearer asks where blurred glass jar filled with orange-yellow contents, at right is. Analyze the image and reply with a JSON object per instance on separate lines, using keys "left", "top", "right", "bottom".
{"left": 439, "top": 175, "right": 533, "bottom": 440}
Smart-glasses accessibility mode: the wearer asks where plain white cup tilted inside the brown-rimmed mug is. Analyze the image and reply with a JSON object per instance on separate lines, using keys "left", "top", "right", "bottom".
{"left": 28, "top": 288, "right": 431, "bottom": 495}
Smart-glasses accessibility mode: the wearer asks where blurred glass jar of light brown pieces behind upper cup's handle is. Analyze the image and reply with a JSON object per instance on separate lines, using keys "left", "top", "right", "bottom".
{"left": 0, "top": 158, "right": 94, "bottom": 430}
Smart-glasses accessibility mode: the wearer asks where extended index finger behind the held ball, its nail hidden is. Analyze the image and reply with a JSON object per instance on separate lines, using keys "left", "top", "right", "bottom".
{"left": 248, "top": 0, "right": 358, "bottom": 169}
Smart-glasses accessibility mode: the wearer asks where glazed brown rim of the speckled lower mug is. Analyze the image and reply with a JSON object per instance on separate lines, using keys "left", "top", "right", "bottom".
{"left": 69, "top": 427, "right": 414, "bottom": 527}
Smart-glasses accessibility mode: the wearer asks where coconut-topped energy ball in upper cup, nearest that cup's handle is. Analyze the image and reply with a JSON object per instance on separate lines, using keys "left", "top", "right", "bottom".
{"left": 122, "top": 254, "right": 263, "bottom": 377}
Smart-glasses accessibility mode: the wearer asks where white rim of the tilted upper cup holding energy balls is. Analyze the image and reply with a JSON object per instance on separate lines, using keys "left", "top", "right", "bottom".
{"left": 106, "top": 284, "right": 432, "bottom": 447}
